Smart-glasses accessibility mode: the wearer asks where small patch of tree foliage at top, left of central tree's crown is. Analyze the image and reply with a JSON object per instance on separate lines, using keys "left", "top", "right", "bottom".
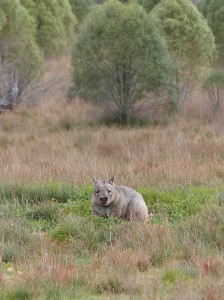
{"left": 69, "top": 0, "right": 94, "bottom": 22}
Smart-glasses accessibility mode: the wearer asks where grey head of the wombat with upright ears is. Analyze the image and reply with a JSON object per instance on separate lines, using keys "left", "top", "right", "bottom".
{"left": 93, "top": 177, "right": 115, "bottom": 206}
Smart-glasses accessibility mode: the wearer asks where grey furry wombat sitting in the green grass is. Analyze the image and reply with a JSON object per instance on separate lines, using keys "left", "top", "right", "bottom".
{"left": 91, "top": 177, "right": 148, "bottom": 221}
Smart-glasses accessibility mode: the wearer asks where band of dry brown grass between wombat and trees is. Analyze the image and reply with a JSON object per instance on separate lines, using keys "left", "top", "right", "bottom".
{"left": 0, "top": 76, "right": 224, "bottom": 187}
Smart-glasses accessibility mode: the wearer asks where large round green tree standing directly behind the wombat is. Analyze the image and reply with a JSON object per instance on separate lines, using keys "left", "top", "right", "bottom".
{"left": 72, "top": 0, "right": 176, "bottom": 123}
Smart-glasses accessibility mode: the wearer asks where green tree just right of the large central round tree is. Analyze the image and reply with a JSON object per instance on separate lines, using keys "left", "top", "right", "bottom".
{"left": 151, "top": 0, "right": 215, "bottom": 100}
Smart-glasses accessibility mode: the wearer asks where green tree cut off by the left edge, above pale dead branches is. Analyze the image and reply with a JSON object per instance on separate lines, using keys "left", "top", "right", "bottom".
{"left": 0, "top": 0, "right": 43, "bottom": 108}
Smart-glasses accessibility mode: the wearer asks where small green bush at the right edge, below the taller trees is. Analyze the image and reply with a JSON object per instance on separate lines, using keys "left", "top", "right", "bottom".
{"left": 203, "top": 71, "right": 224, "bottom": 116}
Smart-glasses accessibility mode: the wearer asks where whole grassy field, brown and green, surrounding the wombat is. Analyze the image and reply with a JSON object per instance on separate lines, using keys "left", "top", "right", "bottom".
{"left": 0, "top": 60, "right": 224, "bottom": 300}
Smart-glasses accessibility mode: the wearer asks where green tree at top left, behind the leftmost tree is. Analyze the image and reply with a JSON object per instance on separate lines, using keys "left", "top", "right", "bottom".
{"left": 21, "top": 0, "right": 76, "bottom": 56}
